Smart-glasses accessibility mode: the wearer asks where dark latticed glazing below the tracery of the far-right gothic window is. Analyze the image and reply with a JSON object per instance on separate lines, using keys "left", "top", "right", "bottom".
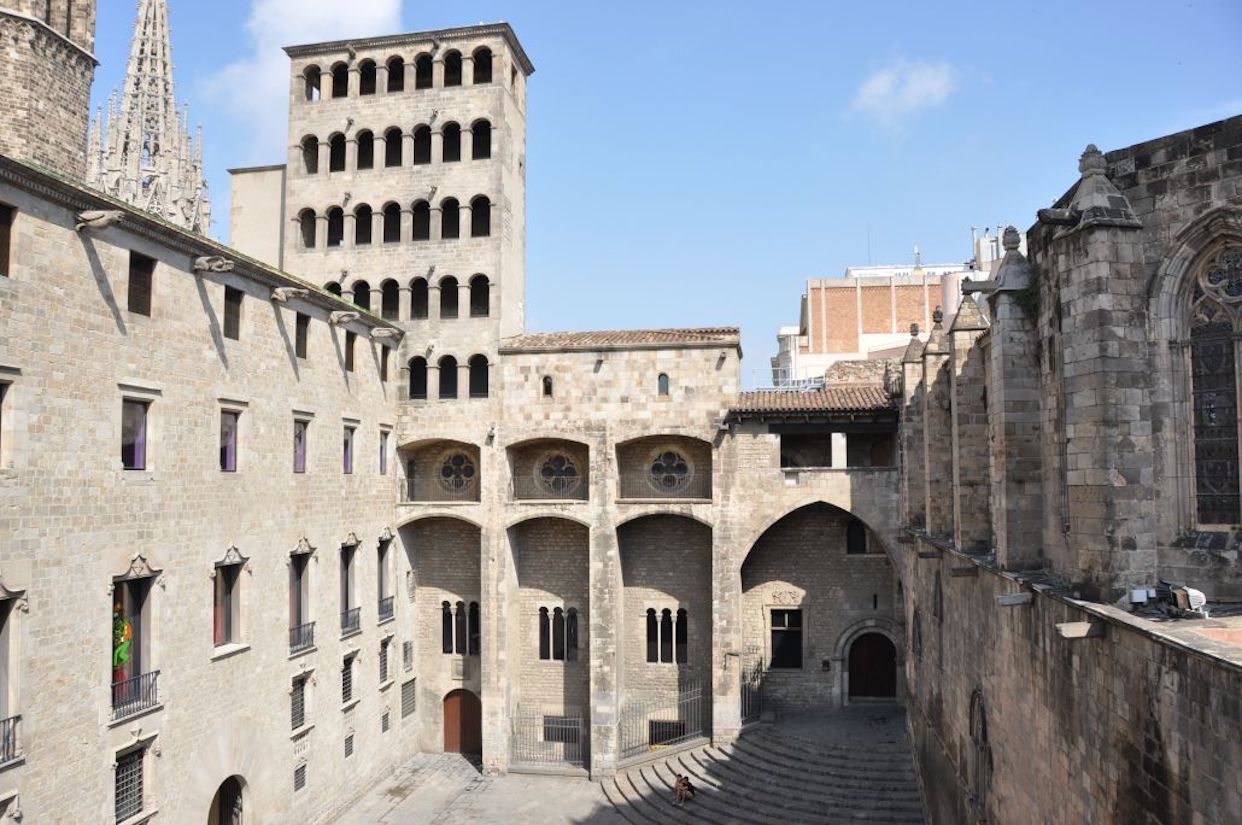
{"left": 1190, "top": 298, "right": 1242, "bottom": 526}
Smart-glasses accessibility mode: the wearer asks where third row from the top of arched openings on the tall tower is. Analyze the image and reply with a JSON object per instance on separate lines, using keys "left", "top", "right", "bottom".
{"left": 298, "top": 195, "right": 492, "bottom": 250}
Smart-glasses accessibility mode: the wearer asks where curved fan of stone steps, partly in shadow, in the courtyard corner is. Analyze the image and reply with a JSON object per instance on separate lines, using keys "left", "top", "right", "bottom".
{"left": 604, "top": 708, "right": 927, "bottom": 825}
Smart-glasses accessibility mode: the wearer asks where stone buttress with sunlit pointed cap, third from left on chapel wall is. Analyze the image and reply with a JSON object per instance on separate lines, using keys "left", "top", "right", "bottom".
{"left": 949, "top": 296, "right": 992, "bottom": 553}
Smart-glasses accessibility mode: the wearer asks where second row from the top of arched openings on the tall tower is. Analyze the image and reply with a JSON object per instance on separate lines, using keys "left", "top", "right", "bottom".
{"left": 299, "top": 118, "right": 492, "bottom": 175}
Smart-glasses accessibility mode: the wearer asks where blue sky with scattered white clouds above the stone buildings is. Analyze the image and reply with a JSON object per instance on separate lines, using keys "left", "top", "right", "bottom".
{"left": 94, "top": 0, "right": 1242, "bottom": 383}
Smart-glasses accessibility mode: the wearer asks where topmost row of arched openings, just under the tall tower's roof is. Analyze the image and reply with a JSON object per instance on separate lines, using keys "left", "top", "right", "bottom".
{"left": 302, "top": 46, "right": 496, "bottom": 102}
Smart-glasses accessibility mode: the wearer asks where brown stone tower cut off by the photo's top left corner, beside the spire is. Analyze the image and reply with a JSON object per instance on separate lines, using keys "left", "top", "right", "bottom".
{"left": 0, "top": 0, "right": 96, "bottom": 178}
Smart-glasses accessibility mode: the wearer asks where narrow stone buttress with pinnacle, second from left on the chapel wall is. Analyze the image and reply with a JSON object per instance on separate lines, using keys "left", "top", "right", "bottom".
{"left": 923, "top": 313, "right": 953, "bottom": 538}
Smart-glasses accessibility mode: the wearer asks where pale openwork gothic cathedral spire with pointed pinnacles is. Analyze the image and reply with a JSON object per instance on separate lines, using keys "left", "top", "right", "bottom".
{"left": 87, "top": 0, "right": 211, "bottom": 234}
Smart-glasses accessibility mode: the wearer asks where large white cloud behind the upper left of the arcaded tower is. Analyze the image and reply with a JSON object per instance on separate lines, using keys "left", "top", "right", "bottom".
{"left": 205, "top": 0, "right": 401, "bottom": 163}
